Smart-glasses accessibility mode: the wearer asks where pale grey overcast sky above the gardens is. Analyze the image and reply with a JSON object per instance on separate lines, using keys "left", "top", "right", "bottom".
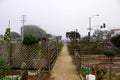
{"left": 0, "top": 0, "right": 120, "bottom": 36}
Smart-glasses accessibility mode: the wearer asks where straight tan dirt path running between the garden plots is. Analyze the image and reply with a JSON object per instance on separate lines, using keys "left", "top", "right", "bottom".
{"left": 52, "top": 44, "right": 80, "bottom": 80}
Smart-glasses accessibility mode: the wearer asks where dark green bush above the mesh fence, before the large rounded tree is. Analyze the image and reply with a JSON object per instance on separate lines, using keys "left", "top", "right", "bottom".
{"left": 23, "top": 35, "right": 39, "bottom": 45}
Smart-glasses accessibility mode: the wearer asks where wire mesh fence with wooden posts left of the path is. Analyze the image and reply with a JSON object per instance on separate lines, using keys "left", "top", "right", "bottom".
{"left": 0, "top": 41, "right": 59, "bottom": 80}
